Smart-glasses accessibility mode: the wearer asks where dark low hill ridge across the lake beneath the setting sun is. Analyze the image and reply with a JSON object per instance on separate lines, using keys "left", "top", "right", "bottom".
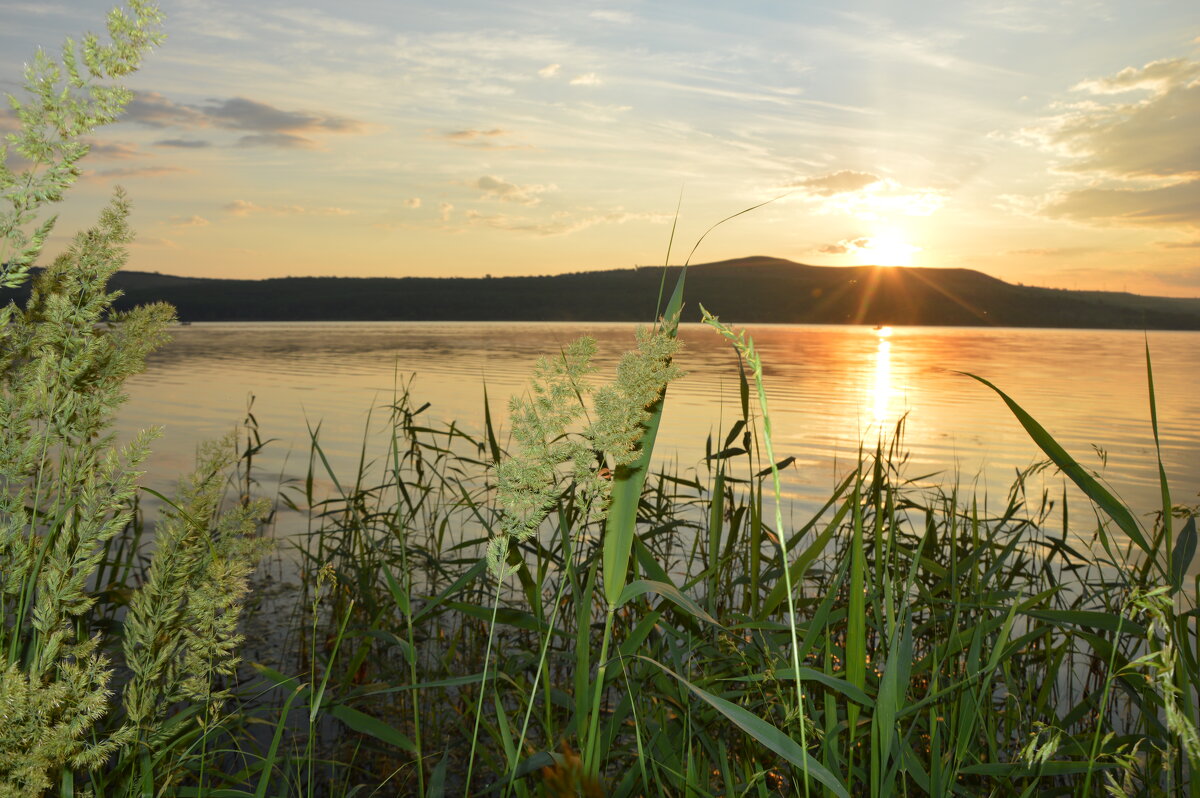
{"left": 4, "top": 256, "right": 1200, "bottom": 330}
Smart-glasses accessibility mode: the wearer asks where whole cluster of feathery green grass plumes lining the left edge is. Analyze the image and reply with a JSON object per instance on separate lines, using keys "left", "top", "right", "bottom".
{"left": 0, "top": 0, "right": 264, "bottom": 796}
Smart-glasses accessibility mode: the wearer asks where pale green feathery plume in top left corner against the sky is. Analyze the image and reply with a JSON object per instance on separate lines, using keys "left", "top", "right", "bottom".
{"left": 0, "top": 0, "right": 163, "bottom": 289}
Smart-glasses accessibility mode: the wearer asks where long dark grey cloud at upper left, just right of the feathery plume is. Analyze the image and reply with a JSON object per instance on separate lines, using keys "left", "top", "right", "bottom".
{"left": 122, "top": 91, "right": 368, "bottom": 149}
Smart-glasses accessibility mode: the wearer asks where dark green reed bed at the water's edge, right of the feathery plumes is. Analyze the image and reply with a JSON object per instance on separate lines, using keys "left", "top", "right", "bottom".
{"left": 201, "top": 321, "right": 1198, "bottom": 796}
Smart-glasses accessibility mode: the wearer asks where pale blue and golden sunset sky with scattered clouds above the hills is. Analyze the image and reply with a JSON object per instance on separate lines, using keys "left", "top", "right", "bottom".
{"left": 0, "top": 0, "right": 1200, "bottom": 296}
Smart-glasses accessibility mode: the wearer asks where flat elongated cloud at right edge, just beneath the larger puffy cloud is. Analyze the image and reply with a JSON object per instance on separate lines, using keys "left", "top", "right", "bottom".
{"left": 1040, "top": 180, "right": 1200, "bottom": 227}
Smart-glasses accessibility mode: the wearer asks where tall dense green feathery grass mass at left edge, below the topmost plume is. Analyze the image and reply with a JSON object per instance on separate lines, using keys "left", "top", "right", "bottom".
{"left": 0, "top": 192, "right": 174, "bottom": 794}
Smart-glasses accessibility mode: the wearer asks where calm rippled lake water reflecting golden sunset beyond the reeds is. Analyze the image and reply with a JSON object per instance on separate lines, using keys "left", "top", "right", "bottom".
{"left": 120, "top": 323, "right": 1200, "bottom": 544}
